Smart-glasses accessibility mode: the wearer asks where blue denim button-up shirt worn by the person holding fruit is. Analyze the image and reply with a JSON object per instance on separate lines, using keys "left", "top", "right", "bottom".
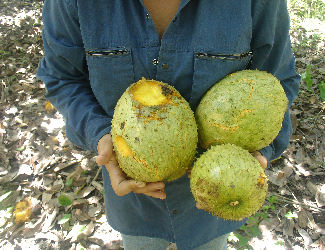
{"left": 38, "top": 0, "right": 300, "bottom": 249}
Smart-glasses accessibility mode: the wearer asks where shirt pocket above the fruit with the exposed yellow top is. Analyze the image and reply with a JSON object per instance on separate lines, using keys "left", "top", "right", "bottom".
{"left": 86, "top": 47, "right": 134, "bottom": 114}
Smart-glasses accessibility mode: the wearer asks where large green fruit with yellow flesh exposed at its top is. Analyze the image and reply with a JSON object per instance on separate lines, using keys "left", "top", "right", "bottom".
{"left": 111, "top": 78, "right": 198, "bottom": 182}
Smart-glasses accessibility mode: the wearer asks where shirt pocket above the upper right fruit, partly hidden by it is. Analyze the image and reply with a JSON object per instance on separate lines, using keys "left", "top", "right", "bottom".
{"left": 190, "top": 51, "right": 252, "bottom": 109}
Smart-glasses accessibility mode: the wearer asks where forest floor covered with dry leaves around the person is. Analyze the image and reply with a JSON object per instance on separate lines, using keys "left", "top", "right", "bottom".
{"left": 0, "top": 0, "right": 325, "bottom": 250}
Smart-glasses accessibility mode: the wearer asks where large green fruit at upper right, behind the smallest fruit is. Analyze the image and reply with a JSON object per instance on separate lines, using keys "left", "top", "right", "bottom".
{"left": 195, "top": 70, "right": 288, "bottom": 152}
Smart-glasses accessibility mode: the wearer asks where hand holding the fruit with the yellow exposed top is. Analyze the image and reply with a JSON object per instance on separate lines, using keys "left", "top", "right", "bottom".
{"left": 96, "top": 134, "right": 166, "bottom": 199}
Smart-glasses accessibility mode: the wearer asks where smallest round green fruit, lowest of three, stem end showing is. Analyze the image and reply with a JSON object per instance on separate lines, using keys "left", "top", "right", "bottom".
{"left": 190, "top": 144, "right": 267, "bottom": 220}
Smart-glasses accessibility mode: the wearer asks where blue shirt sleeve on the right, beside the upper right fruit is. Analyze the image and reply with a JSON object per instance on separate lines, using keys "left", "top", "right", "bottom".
{"left": 251, "top": 0, "right": 300, "bottom": 162}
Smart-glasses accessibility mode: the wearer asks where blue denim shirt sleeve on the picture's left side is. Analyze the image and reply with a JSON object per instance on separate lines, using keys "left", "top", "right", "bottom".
{"left": 37, "top": 0, "right": 111, "bottom": 151}
